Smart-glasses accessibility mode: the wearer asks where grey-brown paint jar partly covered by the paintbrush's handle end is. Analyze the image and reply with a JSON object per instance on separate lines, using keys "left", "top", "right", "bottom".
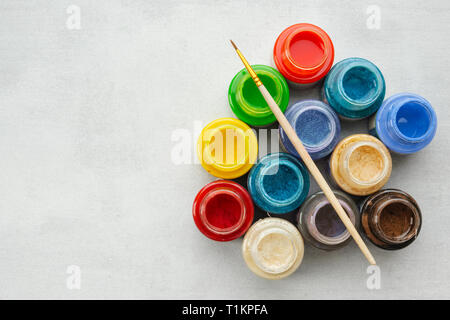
{"left": 297, "top": 191, "right": 359, "bottom": 250}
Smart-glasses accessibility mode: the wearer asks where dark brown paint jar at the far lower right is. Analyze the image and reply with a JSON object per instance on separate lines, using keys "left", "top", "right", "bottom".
{"left": 361, "top": 189, "right": 422, "bottom": 250}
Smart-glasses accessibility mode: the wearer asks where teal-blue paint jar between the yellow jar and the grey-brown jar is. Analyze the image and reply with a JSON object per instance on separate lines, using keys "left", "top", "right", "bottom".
{"left": 248, "top": 152, "right": 309, "bottom": 213}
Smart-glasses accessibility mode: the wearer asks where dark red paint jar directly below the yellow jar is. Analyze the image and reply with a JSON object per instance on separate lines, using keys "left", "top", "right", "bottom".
{"left": 192, "top": 180, "right": 254, "bottom": 241}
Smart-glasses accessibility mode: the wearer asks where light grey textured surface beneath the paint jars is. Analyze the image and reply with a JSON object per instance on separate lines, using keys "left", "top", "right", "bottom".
{"left": 0, "top": 0, "right": 450, "bottom": 299}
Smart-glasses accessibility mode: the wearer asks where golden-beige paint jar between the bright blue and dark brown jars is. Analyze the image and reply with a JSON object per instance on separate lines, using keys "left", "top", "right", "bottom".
{"left": 330, "top": 134, "right": 392, "bottom": 196}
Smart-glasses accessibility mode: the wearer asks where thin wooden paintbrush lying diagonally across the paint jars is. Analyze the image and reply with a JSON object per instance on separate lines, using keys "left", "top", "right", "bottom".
{"left": 230, "top": 40, "right": 376, "bottom": 265}
